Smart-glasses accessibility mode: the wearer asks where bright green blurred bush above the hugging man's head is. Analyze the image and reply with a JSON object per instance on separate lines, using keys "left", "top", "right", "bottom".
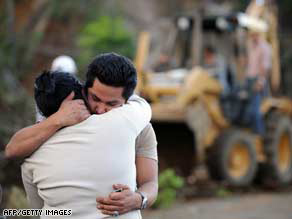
{"left": 77, "top": 16, "right": 134, "bottom": 68}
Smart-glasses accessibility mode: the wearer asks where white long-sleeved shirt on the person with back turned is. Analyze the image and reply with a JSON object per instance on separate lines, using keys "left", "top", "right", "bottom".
{"left": 22, "top": 96, "right": 151, "bottom": 219}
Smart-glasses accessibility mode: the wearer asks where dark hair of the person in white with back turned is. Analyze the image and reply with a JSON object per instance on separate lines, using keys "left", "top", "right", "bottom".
{"left": 34, "top": 71, "right": 83, "bottom": 117}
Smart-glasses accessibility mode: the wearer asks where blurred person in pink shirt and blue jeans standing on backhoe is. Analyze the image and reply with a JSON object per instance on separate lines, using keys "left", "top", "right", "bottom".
{"left": 246, "top": 31, "right": 272, "bottom": 135}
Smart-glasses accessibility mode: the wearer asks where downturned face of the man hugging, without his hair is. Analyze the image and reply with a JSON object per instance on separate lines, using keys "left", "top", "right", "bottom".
{"left": 88, "top": 79, "right": 125, "bottom": 114}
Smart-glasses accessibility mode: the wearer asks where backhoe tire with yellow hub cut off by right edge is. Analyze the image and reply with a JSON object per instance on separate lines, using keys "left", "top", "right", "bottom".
{"left": 259, "top": 112, "right": 292, "bottom": 186}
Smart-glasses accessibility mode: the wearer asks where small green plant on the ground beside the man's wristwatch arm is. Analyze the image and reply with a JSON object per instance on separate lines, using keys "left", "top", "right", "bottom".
{"left": 154, "top": 169, "right": 184, "bottom": 208}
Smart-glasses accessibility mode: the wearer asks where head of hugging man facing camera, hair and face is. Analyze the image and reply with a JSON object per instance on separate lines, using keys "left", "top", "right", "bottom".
{"left": 85, "top": 53, "right": 137, "bottom": 114}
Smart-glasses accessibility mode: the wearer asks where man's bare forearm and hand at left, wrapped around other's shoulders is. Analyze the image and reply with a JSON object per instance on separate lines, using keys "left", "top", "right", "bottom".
{"left": 5, "top": 92, "right": 90, "bottom": 158}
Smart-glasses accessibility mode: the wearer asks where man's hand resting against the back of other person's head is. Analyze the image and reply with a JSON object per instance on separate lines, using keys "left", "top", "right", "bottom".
{"left": 53, "top": 91, "right": 90, "bottom": 127}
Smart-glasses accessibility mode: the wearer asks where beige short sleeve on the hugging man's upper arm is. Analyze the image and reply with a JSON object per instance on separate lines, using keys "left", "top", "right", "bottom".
{"left": 136, "top": 123, "right": 158, "bottom": 161}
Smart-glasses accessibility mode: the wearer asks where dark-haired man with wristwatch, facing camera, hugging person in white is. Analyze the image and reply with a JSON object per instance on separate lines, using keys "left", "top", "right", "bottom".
{"left": 6, "top": 53, "right": 158, "bottom": 215}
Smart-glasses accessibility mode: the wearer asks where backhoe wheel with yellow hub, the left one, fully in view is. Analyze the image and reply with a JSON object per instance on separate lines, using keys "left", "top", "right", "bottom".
{"left": 207, "top": 130, "right": 258, "bottom": 187}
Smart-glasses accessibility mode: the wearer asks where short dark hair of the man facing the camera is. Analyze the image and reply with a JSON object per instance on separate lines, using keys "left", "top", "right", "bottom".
{"left": 85, "top": 53, "right": 137, "bottom": 100}
